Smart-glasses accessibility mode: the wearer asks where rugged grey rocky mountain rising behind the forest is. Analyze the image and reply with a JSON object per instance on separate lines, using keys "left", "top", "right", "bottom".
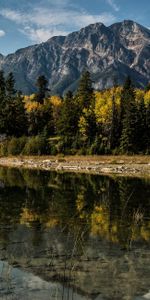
{"left": 0, "top": 20, "right": 150, "bottom": 94}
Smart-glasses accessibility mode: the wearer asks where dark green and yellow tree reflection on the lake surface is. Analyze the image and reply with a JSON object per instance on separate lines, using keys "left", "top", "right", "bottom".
{"left": 0, "top": 168, "right": 150, "bottom": 250}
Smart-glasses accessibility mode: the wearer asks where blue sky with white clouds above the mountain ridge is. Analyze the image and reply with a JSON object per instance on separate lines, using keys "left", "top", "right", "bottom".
{"left": 0, "top": 0, "right": 150, "bottom": 55}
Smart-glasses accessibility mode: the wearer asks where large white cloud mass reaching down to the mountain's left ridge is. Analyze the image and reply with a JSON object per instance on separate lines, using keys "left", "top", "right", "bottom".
{"left": 0, "top": 6, "right": 115, "bottom": 43}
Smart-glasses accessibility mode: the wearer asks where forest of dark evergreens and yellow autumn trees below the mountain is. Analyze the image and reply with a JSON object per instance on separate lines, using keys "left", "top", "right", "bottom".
{"left": 0, "top": 71, "right": 150, "bottom": 156}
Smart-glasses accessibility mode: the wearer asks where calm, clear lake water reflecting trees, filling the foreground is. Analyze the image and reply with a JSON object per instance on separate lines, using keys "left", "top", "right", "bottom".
{"left": 0, "top": 168, "right": 150, "bottom": 300}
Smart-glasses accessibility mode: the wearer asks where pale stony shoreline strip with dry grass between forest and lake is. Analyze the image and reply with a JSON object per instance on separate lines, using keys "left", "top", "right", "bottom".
{"left": 0, "top": 155, "right": 150, "bottom": 177}
